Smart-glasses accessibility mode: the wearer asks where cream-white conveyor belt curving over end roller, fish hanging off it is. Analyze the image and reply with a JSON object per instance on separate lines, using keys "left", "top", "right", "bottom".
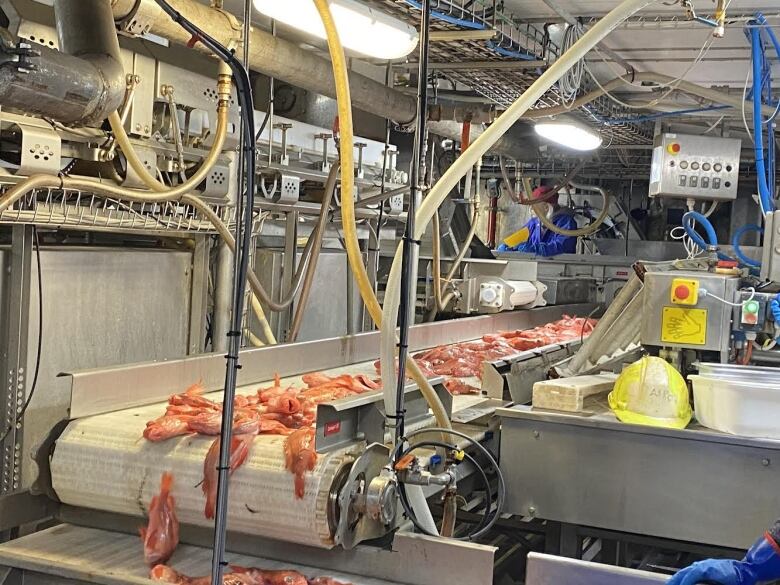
{"left": 51, "top": 388, "right": 358, "bottom": 548}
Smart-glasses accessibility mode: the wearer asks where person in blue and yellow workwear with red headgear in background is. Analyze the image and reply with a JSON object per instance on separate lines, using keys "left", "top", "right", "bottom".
{"left": 498, "top": 187, "right": 578, "bottom": 256}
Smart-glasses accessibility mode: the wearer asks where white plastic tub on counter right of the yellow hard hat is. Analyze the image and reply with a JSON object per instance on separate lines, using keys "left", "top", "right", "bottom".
{"left": 689, "top": 376, "right": 780, "bottom": 439}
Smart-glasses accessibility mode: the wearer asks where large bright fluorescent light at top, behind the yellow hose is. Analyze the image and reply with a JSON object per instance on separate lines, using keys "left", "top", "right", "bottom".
{"left": 254, "top": 0, "right": 418, "bottom": 60}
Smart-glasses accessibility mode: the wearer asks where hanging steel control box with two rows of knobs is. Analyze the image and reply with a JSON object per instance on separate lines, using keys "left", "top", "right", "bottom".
{"left": 650, "top": 134, "right": 742, "bottom": 201}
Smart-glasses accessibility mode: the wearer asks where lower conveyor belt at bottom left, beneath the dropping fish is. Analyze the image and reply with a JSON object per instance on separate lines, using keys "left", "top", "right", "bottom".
{"left": 0, "top": 524, "right": 398, "bottom": 585}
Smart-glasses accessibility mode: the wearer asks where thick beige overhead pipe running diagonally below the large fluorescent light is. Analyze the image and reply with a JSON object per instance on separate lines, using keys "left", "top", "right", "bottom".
{"left": 112, "top": 0, "right": 417, "bottom": 124}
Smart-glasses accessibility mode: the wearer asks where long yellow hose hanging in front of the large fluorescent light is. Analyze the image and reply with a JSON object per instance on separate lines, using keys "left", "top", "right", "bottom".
{"left": 314, "top": 0, "right": 452, "bottom": 428}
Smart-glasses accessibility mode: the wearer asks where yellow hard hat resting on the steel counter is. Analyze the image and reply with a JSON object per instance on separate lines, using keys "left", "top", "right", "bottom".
{"left": 609, "top": 357, "right": 693, "bottom": 429}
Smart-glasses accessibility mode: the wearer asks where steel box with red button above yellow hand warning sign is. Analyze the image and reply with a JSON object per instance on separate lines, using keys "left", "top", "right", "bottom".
{"left": 641, "top": 271, "right": 739, "bottom": 352}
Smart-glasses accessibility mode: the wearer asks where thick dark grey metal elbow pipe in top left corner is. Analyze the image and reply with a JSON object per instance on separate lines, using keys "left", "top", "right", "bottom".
{"left": 0, "top": 0, "right": 126, "bottom": 125}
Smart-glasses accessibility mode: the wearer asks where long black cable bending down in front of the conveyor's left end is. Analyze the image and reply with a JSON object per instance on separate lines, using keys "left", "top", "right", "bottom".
{"left": 155, "top": 0, "right": 256, "bottom": 585}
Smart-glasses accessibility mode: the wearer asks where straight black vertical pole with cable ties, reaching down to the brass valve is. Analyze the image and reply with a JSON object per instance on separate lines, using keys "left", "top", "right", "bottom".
{"left": 396, "top": 0, "right": 431, "bottom": 450}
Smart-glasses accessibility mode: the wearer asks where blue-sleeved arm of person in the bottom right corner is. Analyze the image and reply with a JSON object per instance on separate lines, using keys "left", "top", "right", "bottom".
{"left": 668, "top": 520, "right": 780, "bottom": 585}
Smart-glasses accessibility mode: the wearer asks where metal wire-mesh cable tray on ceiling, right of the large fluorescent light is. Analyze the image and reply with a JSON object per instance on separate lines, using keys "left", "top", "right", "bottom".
{"left": 366, "top": 0, "right": 652, "bottom": 145}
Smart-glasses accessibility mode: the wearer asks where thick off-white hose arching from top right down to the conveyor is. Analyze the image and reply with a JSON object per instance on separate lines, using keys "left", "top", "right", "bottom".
{"left": 380, "top": 0, "right": 657, "bottom": 400}
